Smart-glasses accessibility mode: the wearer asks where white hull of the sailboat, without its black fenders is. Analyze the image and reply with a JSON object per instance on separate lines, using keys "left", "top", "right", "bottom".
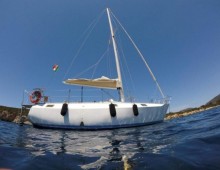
{"left": 29, "top": 102, "right": 169, "bottom": 130}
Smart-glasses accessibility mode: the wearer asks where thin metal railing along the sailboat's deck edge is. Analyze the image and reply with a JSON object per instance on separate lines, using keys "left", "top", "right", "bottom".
{"left": 22, "top": 88, "right": 171, "bottom": 107}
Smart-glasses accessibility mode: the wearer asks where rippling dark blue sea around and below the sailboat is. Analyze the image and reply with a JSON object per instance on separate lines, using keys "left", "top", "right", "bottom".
{"left": 0, "top": 107, "right": 220, "bottom": 170}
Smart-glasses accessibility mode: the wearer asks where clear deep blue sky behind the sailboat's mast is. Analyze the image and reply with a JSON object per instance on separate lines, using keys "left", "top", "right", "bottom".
{"left": 0, "top": 0, "right": 220, "bottom": 111}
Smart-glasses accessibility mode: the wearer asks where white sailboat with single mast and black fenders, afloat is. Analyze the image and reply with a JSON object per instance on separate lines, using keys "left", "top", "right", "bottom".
{"left": 28, "top": 8, "right": 169, "bottom": 130}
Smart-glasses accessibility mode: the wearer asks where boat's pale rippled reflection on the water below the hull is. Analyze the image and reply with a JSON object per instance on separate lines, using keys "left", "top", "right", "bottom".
{"left": 12, "top": 124, "right": 168, "bottom": 169}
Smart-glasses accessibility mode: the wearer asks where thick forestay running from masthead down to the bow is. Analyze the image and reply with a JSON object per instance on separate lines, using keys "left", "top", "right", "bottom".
{"left": 111, "top": 12, "right": 165, "bottom": 98}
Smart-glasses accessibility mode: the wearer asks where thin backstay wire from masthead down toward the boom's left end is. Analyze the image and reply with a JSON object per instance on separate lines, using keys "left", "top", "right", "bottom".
{"left": 63, "top": 11, "right": 105, "bottom": 79}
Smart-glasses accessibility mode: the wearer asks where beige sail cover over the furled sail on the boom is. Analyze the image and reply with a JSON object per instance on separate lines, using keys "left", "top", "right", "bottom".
{"left": 63, "top": 76, "right": 121, "bottom": 89}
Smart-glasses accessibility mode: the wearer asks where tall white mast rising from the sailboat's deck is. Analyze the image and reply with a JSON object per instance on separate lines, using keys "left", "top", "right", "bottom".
{"left": 107, "top": 8, "right": 125, "bottom": 102}
